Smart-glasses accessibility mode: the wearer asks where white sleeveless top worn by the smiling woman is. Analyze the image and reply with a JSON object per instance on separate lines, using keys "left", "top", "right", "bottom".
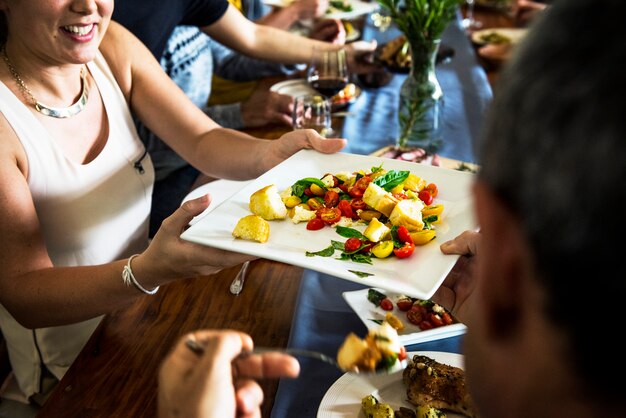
{"left": 0, "top": 53, "right": 154, "bottom": 396}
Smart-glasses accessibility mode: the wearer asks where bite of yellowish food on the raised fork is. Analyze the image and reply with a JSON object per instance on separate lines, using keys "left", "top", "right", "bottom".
{"left": 337, "top": 323, "right": 407, "bottom": 373}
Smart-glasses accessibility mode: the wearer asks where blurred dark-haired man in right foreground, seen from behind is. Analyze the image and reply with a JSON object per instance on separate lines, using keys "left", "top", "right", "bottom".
{"left": 435, "top": 0, "right": 626, "bottom": 418}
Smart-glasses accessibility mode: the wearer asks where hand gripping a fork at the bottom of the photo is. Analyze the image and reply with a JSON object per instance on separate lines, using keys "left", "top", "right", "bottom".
{"left": 158, "top": 330, "right": 300, "bottom": 418}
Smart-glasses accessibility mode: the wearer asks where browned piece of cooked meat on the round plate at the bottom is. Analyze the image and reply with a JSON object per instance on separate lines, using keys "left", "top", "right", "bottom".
{"left": 402, "top": 355, "right": 476, "bottom": 418}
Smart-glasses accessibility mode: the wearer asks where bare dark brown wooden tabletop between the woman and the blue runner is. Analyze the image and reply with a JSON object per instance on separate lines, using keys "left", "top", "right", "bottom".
{"left": 37, "top": 259, "right": 302, "bottom": 418}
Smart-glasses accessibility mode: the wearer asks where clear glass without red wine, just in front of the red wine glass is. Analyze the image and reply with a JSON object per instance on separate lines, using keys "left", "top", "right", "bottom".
{"left": 292, "top": 94, "right": 334, "bottom": 138}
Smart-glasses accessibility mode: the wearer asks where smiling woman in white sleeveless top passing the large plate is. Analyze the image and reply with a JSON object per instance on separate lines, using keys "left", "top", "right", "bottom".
{"left": 0, "top": 0, "right": 346, "bottom": 412}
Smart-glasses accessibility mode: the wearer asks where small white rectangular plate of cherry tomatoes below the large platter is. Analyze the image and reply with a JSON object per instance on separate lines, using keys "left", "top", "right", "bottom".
{"left": 342, "top": 289, "right": 467, "bottom": 345}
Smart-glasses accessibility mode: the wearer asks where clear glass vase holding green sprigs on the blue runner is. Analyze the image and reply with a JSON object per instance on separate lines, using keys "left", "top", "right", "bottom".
{"left": 396, "top": 38, "right": 443, "bottom": 153}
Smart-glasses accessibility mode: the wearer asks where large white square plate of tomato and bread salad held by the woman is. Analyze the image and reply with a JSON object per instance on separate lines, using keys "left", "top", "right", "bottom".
{"left": 181, "top": 150, "right": 477, "bottom": 299}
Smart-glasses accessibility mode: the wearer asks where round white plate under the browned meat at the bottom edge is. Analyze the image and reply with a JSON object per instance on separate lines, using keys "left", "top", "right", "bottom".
{"left": 317, "top": 351, "right": 464, "bottom": 418}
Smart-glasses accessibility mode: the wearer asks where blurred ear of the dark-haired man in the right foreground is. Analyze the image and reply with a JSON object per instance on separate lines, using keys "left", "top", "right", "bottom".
{"left": 474, "top": 182, "right": 529, "bottom": 339}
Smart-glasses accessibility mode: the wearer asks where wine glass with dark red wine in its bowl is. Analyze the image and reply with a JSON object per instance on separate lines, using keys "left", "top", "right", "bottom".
{"left": 307, "top": 49, "right": 349, "bottom": 98}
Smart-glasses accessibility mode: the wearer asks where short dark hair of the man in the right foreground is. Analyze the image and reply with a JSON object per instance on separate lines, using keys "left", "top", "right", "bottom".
{"left": 479, "top": 0, "right": 626, "bottom": 402}
